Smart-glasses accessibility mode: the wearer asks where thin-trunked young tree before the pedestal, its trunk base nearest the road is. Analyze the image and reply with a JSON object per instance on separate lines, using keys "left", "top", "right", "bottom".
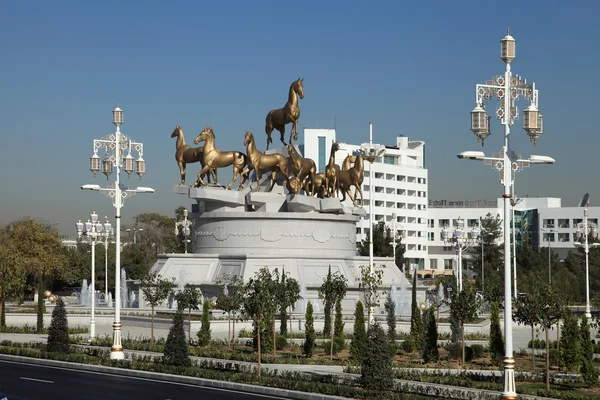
{"left": 244, "top": 268, "right": 277, "bottom": 376}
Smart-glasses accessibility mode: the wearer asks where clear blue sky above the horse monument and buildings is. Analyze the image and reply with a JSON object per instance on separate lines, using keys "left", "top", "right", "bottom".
{"left": 0, "top": 1, "right": 600, "bottom": 236}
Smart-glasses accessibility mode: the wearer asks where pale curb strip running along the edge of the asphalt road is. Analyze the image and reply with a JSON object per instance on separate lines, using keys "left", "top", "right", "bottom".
{"left": 0, "top": 354, "right": 348, "bottom": 400}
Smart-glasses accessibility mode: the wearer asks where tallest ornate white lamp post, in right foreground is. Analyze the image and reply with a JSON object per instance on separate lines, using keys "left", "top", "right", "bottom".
{"left": 458, "top": 30, "right": 554, "bottom": 400}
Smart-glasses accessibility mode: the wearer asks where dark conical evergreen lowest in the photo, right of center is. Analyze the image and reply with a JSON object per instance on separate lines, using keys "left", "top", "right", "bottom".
{"left": 361, "top": 323, "right": 394, "bottom": 392}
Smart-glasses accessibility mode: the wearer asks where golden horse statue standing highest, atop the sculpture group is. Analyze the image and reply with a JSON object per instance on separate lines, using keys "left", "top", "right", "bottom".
{"left": 265, "top": 78, "right": 304, "bottom": 150}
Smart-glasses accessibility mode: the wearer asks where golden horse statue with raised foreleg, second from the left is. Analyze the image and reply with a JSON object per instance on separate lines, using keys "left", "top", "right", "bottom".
{"left": 194, "top": 126, "right": 247, "bottom": 189}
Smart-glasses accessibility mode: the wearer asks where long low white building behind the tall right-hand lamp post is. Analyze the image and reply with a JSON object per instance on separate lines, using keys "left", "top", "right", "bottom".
{"left": 422, "top": 197, "right": 600, "bottom": 275}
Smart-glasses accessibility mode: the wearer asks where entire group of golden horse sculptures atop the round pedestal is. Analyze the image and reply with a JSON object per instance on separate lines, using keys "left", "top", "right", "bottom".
{"left": 171, "top": 78, "right": 373, "bottom": 206}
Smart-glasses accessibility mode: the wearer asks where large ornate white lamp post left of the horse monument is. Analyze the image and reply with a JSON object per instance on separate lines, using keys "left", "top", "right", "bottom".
{"left": 81, "top": 105, "right": 154, "bottom": 360}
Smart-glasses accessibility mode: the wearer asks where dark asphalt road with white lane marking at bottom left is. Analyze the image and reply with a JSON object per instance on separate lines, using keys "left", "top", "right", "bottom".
{"left": 0, "top": 360, "right": 282, "bottom": 400}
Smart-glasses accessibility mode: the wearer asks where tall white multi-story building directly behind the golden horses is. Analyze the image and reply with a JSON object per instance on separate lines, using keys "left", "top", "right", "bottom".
{"left": 303, "top": 129, "right": 428, "bottom": 268}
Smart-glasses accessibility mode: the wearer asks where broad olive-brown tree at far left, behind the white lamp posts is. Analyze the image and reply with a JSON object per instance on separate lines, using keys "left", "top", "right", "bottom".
{"left": 12, "top": 218, "right": 66, "bottom": 333}
